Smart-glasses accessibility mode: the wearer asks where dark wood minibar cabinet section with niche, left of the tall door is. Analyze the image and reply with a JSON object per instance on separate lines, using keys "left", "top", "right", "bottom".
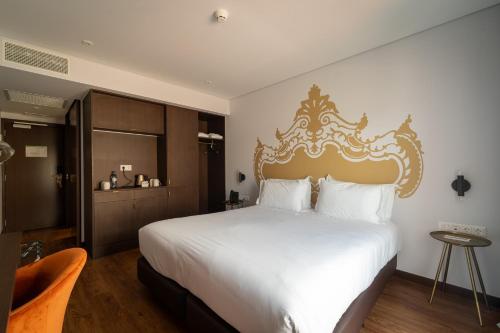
{"left": 83, "top": 91, "right": 168, "bottom": 258}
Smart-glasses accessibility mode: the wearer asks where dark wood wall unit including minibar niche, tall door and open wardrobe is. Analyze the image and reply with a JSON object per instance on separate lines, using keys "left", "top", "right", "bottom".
{"left": 83, "top": 90, "right": 225, "bottom": 258}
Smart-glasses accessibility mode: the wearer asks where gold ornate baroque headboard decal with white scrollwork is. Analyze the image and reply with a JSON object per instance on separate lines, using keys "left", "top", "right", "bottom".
{"left": 254, "top": 85, "right": 423, "bottom": 202}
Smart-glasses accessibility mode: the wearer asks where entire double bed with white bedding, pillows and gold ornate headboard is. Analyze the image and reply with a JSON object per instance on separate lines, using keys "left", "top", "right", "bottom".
{"left": 138, "top": 85, "right": 423, "bottom": 333}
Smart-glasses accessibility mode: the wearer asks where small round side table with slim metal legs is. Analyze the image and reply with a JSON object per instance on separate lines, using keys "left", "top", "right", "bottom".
{"left": 429, "top": 231, "right": 491, "bottom": 326}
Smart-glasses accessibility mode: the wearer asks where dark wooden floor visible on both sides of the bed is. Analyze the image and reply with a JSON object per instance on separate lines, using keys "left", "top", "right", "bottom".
{"left": 63, "top": 250, "right": 500, "bottom": 333}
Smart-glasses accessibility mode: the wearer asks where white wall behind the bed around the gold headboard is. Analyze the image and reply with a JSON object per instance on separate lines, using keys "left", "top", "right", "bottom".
{"left": 227, "top": 6, "right": 500, "bottom": 296}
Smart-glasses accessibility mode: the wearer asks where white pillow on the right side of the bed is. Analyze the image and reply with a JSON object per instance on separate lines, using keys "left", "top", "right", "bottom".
{"left": 316, "top": 181, "right": 382, "bottom": 223}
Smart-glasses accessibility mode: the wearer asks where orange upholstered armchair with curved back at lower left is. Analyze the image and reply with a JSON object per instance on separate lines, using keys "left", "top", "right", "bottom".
{"left": 7, "top": 248, "right": 87, "bottom": 333}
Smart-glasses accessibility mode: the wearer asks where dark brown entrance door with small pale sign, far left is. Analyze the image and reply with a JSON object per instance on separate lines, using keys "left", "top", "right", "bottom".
{"left": 2, "top": 119, "right": 64, "bottom": 232}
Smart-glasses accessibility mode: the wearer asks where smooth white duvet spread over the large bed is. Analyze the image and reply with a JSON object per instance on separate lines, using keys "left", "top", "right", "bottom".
{"left": 139, "top": 206, "right": 398, "bottom": 333}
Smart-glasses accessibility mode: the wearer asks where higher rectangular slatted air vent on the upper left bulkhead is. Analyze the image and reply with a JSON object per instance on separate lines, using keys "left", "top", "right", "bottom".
{"left": 4, "top": 42, "right": 69, "bottom": 75}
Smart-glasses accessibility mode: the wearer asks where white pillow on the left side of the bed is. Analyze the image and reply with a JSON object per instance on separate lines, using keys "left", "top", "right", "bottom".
{"left": 257, "top": 177, "right": 311, "bottom": 212}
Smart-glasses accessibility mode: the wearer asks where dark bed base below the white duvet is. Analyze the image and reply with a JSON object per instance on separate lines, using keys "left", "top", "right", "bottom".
{"left": 137, "top": 256, "right": 397, "bottom": 333}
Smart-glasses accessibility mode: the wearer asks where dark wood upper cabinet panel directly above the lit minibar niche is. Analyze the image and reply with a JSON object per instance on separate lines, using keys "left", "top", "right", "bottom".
{"left": 92, "top": 92, "right": 164, "bottom": 134}
